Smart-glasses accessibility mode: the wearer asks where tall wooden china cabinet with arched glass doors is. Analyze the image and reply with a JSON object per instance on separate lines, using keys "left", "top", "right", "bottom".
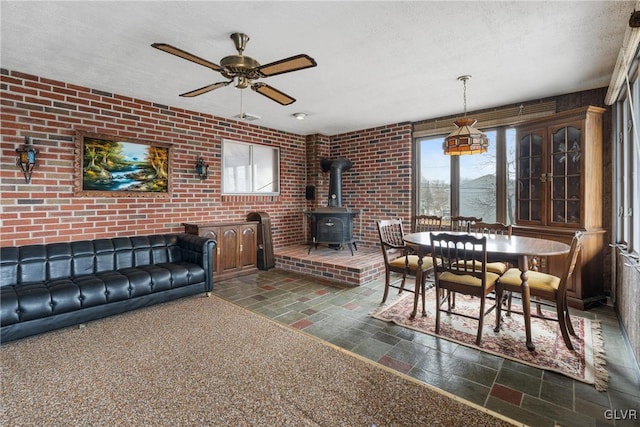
{"left": 513, "top": 106, "right": 606, "bottom": 309}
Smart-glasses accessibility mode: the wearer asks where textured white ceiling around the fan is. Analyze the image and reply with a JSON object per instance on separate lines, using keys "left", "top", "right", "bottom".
{"left": 0, "top": 1, "right": 640, "bottom": 135}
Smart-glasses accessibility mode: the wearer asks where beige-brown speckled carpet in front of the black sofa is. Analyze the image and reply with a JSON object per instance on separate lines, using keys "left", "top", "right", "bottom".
{"left": 0, "top": 296, "right": 515, "bottom": 426}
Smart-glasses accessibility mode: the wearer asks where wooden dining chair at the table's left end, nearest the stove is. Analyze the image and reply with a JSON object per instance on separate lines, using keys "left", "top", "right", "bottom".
{"left": 377, "top": 218, "right": 433, "bottom": 308}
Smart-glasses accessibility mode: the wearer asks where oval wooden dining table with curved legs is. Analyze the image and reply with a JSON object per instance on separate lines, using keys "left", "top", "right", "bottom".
{"left": 404, "top": 231, "right": 570, "bottom": 351}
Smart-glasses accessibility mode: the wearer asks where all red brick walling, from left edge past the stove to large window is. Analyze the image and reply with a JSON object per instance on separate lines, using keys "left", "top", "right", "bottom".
{"left": 0, "top": 69, "right": 411, "bottom": 251}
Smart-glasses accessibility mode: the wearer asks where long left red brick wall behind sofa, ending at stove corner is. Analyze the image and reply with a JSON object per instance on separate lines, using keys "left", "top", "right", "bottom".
{"left": 0, "top": 70, "right": 306, "bottom": 246}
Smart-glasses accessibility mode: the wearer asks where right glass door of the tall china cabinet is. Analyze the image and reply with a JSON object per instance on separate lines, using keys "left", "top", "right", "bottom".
{"left": 545, "top": 126, "right": 582, "bottom": 225}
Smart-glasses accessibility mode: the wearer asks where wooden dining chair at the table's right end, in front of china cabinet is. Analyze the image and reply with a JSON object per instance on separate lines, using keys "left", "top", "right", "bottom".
{"left": 495, "top": 231, "right": 583, "bottom": 350}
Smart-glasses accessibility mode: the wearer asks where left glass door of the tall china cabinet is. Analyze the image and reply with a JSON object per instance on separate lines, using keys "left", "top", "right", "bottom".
{"left": 516, "top": 130, "right": 544, "bottom": 222}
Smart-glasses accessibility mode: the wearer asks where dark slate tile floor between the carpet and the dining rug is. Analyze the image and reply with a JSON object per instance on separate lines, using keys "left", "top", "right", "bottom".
{"left": 214, "top": 269, "right": 640, "bottom": 427}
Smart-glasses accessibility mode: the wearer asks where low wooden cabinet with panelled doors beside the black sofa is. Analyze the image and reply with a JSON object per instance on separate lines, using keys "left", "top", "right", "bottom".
{"left": 184, "top": 221, "right": 258, "bottom": 281}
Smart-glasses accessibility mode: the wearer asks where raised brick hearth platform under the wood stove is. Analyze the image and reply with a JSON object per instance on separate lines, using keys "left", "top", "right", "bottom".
{"left": 274, "top": 245, "right": 384, "bottom": 286}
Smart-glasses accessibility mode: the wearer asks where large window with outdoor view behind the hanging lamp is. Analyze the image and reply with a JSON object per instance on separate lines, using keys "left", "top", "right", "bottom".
{"left": 416, "top": 127, "right": 515, "bottom": 224}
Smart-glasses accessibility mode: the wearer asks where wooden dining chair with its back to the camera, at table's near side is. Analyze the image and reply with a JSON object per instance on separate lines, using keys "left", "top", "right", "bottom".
{"left": 430, "top": 233, "right": 499, "bottom": 345}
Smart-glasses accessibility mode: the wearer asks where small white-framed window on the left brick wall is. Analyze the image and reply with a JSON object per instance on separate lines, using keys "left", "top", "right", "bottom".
{"left": 222, "top": 140, "right": 280, "bottom": 195}
